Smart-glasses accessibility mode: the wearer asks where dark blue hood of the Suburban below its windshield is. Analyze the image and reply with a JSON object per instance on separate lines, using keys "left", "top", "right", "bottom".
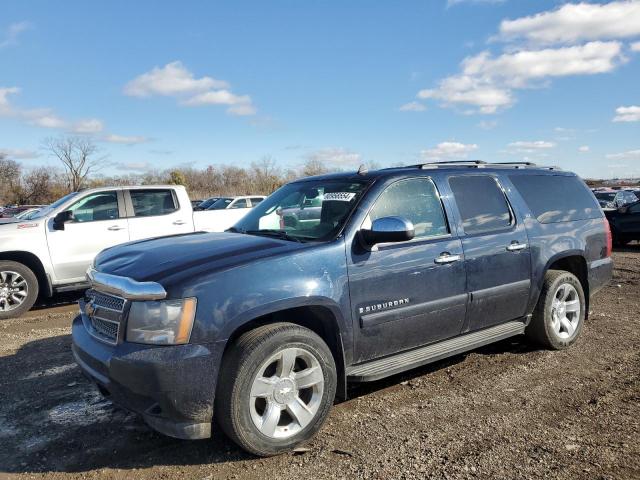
{"left": 95, "top": 232, "right": 304, "bottom": 283}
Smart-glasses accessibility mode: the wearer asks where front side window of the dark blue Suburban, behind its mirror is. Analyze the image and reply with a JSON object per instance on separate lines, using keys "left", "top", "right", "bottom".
{"left": 366, "top": 178, "right": 449, "bottom": 238}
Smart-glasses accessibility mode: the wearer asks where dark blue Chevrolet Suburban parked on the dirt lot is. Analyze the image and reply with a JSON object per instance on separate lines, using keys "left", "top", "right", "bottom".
{"left": 73, "top": 161, "right": 612, "bottom": 455}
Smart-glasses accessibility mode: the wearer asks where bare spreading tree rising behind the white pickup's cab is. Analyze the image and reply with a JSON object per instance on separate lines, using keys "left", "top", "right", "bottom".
{"left": 44, "top": 137, "right": 101, "bottom": 192}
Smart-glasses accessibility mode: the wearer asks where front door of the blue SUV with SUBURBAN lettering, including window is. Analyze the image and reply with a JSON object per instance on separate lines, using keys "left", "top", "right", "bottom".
{"left": 348, "top": 177, "right": 467, "bottom": 363}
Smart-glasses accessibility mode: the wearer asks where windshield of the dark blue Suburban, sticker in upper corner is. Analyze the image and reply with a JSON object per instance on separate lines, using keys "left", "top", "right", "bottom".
{"left": 231, "top": 180, "right": 367, "bottom": 241}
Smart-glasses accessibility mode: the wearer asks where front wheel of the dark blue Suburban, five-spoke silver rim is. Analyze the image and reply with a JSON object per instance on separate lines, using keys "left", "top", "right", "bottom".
{"left": 215, "top": 323, "right": 337, "bottom": 456}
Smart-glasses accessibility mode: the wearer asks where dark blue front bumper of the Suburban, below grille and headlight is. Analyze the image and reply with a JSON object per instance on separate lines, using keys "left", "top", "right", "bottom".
{"left": 72, "top": 315, "right": 223, "bottom": 439}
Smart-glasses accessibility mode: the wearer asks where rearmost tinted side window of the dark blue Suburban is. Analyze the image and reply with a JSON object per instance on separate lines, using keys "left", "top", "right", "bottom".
{"left": 509, "top": 175, "right": 602, "bottom": 223}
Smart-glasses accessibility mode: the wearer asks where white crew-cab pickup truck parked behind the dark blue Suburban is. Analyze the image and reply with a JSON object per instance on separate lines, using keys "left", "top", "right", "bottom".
{"left": 0, "top": 185, "right": 264, "bottom": 319}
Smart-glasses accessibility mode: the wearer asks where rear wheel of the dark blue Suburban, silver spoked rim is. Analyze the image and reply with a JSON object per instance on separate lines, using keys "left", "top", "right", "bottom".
{"left": 525, "top": 270, "right": 586, "bottom": 350}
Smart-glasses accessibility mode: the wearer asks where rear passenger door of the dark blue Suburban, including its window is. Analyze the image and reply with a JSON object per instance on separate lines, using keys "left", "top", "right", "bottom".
{"left": 449, "top": 174, "right": 531, "bottom": 331}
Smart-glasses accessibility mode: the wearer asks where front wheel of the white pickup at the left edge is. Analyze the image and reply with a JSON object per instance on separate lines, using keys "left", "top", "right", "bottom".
{"left": 0, "top": 261, "right": 38, "bottom": 320}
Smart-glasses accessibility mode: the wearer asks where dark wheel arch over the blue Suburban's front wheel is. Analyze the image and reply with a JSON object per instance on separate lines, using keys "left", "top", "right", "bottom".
{"left": 223, "top": 299, "right": 347, "bottom": 400}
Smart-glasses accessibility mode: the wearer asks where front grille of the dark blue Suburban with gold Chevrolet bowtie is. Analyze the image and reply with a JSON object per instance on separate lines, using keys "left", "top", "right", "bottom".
{"left": 84, "top": 290, "right": 125, "bottom": 345}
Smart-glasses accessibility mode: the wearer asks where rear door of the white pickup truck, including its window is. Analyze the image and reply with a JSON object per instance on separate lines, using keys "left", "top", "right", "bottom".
{"left": 125, "top": 188, "right": 193, "bottom": 240}
